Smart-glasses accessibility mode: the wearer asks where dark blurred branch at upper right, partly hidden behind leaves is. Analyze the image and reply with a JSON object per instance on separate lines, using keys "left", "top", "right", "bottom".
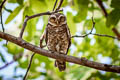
{"left": 96, "top": 0, "right": 120, "bottom": 39}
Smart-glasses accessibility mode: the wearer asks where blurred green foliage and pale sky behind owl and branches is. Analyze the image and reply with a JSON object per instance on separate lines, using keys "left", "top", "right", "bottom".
{"left": 0, "top": 0, "right": 120, "bottom": 80}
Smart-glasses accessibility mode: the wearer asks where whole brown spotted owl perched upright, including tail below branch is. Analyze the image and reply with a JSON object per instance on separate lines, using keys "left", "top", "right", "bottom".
{"left": 40, "top": 13, "right": 71, "bottom": 71}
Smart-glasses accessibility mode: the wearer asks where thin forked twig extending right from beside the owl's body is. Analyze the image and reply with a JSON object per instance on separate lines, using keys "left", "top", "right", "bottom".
{"left": 71, "top": 17, "right": 120, "bottom": 40}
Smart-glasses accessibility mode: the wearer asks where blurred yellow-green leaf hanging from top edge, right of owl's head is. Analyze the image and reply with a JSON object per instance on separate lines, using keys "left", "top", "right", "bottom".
{"left": 74, "top": 0, "right": 89, "bottom": 22}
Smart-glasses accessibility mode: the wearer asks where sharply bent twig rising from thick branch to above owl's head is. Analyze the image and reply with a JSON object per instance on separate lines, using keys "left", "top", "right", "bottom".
{"left": 19, "top": 10, "right": 63, "bottom": 38}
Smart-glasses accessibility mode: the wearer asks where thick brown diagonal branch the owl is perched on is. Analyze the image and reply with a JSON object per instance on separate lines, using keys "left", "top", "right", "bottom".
{"left": 0, "top": 31, "right": 120, "bottom": 73}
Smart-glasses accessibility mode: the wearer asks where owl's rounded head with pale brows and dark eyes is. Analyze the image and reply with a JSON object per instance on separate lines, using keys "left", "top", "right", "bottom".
{"left": 48, "top": 13, "right": 67, "bottom": 26}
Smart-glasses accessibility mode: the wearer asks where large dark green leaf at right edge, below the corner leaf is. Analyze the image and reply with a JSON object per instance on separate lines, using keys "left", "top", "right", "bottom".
{"left": 106, "top": 9, "right": 120, "bottom": 27}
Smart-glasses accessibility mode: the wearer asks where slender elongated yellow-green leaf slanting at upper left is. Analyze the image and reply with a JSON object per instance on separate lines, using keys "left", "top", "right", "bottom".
{"left": 5, "top": 5, "right": 23, "bottom": 24}
